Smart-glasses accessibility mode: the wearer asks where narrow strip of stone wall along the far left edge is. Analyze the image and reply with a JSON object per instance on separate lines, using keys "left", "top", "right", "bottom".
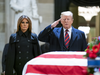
{"left": 0, "top": 0, "right": 5, "bottom": 73}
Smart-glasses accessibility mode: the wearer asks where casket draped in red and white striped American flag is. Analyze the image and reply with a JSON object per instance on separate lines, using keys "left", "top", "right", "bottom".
{"left": 22, "top": 52, "right": 87, "bottom": 75}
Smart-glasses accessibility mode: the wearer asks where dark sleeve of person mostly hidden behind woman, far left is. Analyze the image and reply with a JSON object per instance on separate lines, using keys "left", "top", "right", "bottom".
{"left": 2, "top": 43, "right": 9, "bottom": 72}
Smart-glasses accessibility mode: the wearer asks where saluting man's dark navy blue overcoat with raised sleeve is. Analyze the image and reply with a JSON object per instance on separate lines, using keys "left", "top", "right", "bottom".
{"left": 38, "top": 25, "right": 87, "bottom": 51}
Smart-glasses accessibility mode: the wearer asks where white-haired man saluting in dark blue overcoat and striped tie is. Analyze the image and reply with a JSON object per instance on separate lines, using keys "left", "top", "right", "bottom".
{"left": 38, "top": 11, "right": 87, "bottom": 51}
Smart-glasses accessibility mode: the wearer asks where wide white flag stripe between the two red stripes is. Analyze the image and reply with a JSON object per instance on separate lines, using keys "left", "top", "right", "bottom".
{"left": 27, "top": 58, "right": 87, "bottom": 66}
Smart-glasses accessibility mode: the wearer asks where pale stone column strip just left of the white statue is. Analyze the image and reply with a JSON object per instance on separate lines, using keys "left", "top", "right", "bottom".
{"left": 5, "top": 0, "right": 14, "bottom": 43}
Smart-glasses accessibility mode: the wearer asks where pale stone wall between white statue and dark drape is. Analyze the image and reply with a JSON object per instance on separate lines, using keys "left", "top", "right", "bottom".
{"left": 37, "top": 0, "right": 54, "bottom": 45}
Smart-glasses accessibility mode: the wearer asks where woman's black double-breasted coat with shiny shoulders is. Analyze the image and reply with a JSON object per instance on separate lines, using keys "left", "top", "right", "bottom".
{"left": 5, "top": 33, "right": 41, "bottom": 75}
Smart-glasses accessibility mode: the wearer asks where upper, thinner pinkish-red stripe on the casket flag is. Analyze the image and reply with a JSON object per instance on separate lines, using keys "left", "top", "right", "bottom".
{"left": 36, "top": 54, "right": 84, "bottom": 59}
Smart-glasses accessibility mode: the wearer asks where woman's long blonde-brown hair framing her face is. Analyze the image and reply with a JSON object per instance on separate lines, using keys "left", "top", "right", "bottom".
{"left": 16, "top": 15, "right": 32, "bottom": 32}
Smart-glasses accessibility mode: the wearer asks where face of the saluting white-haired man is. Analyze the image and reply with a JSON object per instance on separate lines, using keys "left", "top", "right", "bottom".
{"left": 61, "top": 15, "right": 73, "bottom": 29}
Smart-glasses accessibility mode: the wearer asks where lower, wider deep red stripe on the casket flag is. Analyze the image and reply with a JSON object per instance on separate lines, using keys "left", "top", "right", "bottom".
{"left": 26, "top": 65, "right": 87, "bottom": 75}
